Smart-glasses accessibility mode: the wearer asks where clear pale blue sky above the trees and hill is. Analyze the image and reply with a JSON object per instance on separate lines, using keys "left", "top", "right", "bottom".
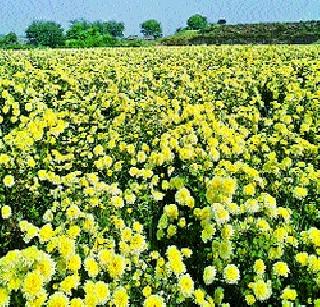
{"left": 0, "top": 0, "right": 320, "bottom": 35}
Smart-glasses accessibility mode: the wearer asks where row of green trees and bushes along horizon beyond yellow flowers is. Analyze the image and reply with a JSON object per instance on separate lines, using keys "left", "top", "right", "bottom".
{"left": 0, "top": 14, "right": 212, "bottom": 48}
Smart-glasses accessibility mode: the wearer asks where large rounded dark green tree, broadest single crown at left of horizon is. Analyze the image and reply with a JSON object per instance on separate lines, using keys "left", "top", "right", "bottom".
{"left": 25, "top": 21, "right": 64, "bottom": 48}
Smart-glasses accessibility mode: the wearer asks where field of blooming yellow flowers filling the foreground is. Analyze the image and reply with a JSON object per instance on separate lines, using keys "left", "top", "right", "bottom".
{"left": 0, "top": 45, "right": 320, "bottom": 307}
